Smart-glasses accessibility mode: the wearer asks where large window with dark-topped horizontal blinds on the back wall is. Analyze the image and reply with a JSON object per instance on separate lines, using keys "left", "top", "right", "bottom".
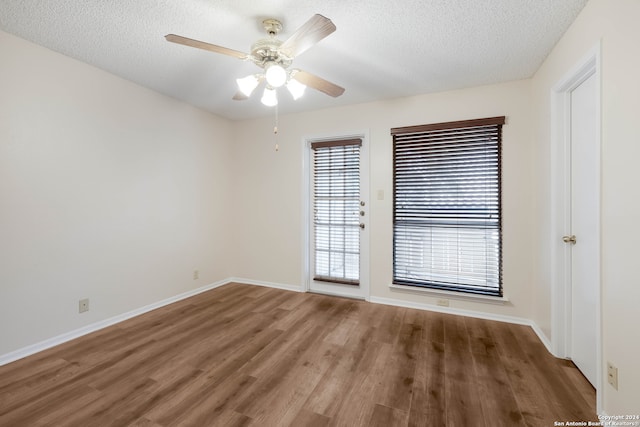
{"left": 391, "top": 117, "right": 505, "bottom": 296}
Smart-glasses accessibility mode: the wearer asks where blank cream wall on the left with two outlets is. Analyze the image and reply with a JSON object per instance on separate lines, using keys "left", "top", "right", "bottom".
{"left": 0, "top": 32, "right": 232, "bottom": 355}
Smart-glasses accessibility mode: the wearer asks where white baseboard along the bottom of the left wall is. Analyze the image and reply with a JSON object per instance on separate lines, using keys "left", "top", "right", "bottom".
{"left": 0, "top": 280, "right": 230, "bottom": 366}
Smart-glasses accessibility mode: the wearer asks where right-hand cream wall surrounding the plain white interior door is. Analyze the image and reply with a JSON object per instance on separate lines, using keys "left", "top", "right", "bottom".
{"left": 532, "top": 0, "right": 640, "bottom": 415}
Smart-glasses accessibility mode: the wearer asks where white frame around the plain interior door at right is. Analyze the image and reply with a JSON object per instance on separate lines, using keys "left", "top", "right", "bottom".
{"left": 549, "top": 43, "right": 603, "bottom": 413}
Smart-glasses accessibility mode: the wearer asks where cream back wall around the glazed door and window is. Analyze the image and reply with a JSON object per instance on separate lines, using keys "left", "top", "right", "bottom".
{"left": 233, "top": 80, "right": 535, "bottom": 319}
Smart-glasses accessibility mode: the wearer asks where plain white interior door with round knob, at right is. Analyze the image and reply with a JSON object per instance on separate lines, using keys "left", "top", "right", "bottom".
{"left": 565, "top": 75, "right": 600, "bottom": 386}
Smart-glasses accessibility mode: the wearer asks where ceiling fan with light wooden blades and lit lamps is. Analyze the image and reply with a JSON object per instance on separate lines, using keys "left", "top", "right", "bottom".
{"left": 165, "top": 14, "right": 344, "bottom": 106}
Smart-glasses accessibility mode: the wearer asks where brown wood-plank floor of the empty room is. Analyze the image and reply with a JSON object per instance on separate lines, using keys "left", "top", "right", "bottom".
{"left": 0, "top": 284, "right": 597, "bottom": 427}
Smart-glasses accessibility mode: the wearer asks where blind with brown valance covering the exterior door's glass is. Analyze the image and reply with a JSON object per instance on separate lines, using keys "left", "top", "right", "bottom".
{"left": 311, "top": 139, "right": 362, "bottom": 285}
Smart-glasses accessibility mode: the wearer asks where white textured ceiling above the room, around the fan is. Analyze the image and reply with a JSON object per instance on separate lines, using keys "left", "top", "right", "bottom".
{"left": 0, "top": 0, "right": 587, "bottom": 119}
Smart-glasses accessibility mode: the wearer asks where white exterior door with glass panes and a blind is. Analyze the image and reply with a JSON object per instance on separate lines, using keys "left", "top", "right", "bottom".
{"left": 308, "top": 136, "right": 368, "bottom": 298}
